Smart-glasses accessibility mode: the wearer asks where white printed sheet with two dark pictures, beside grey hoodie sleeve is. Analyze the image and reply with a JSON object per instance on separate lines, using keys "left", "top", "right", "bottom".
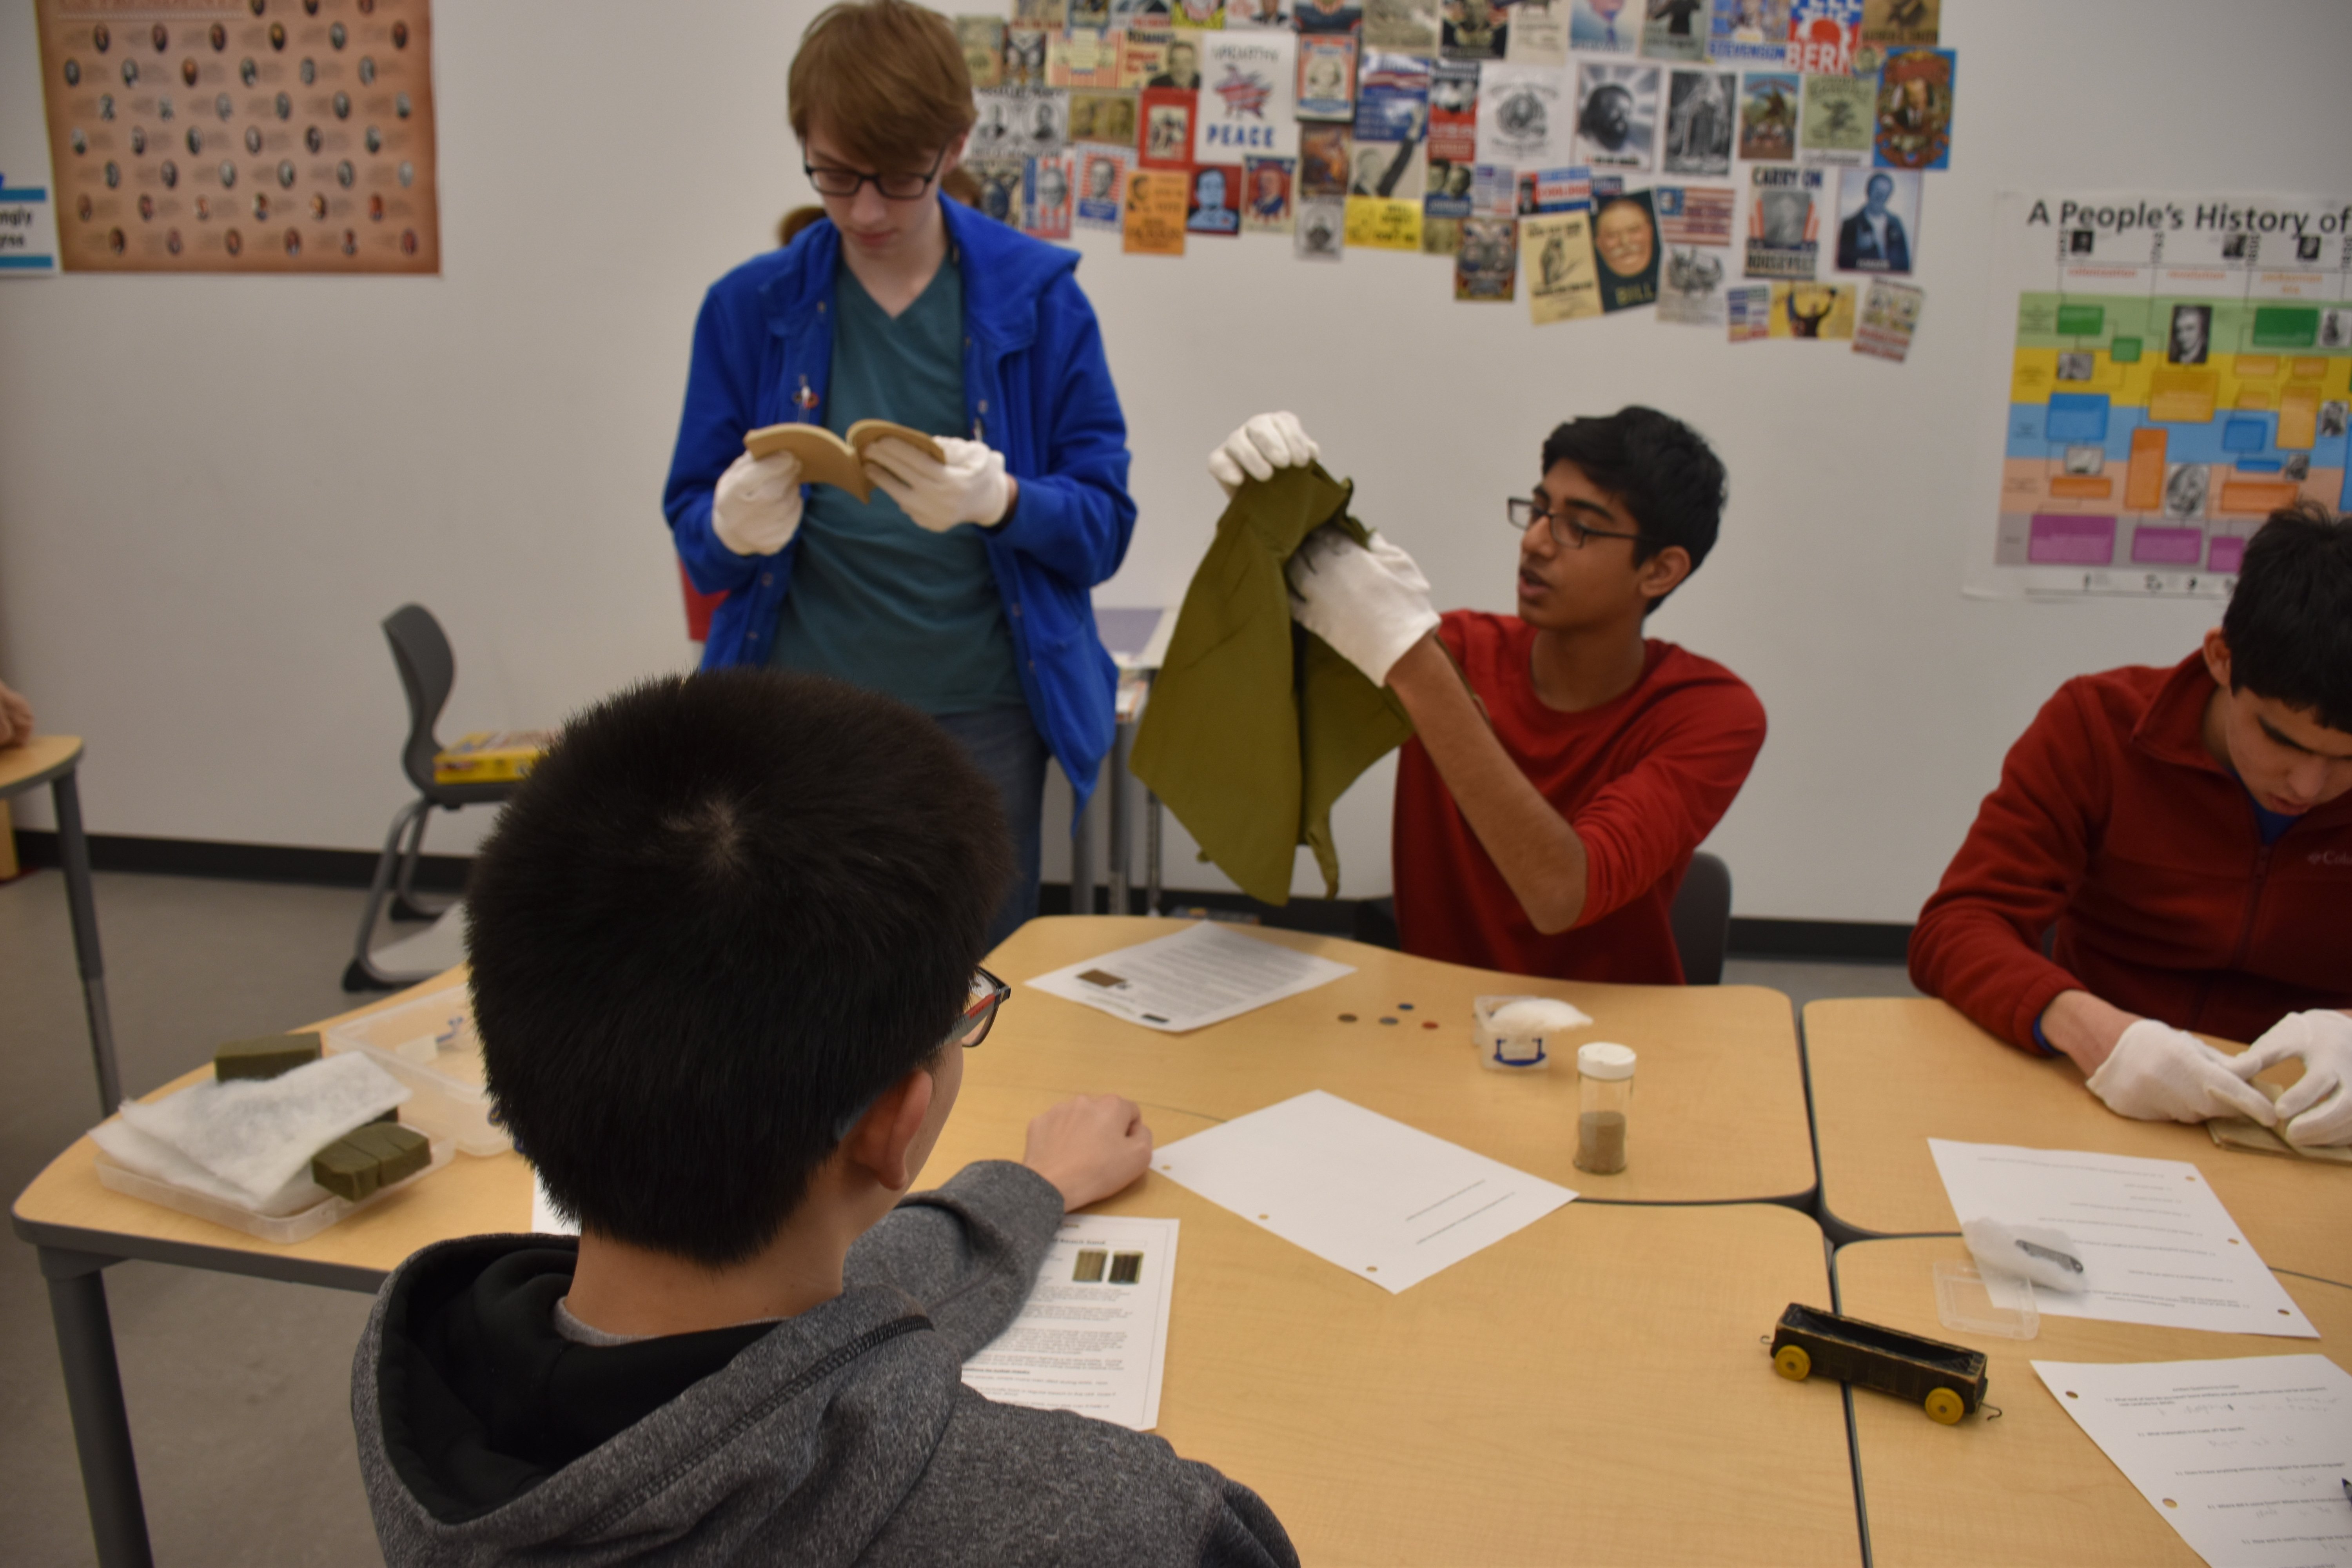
{"left": 964, "top": 1213, "right": 1176, "bottom": 1432}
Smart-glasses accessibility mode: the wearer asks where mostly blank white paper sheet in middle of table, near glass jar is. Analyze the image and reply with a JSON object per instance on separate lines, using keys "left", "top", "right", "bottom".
{"left": 1152, "top": 1089, "right": 1576, "bottom": 1293}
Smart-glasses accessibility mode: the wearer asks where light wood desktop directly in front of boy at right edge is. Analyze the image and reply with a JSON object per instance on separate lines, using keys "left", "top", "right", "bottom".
{"left": 1804, "top": 999, "right": 2352, "bottom": 1283}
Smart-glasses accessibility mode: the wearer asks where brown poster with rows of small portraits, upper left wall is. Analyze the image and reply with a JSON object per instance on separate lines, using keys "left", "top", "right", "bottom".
{"left": 33, "top": 0, "right": 440, "bottom": 273}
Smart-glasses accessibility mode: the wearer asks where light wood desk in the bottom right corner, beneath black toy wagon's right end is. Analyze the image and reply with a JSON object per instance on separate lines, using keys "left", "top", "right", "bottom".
{"left": 1837, "top": 1236, "right": 2352, "bottom": 1568}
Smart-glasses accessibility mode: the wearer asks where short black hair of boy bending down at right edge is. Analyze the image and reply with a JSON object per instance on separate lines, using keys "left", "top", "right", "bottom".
{"left": 2220, "top": 501, "right": 2352, "bottom": 733}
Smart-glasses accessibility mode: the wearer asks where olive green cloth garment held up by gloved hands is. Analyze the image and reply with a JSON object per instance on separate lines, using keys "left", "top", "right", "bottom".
{"left": 1129, "top": 463, "right": 1414, "bottom": 905}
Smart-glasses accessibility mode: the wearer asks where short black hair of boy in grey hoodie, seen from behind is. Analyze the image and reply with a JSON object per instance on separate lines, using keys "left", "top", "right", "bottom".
{"left": 466, "top": 670, "right": 1011, "bottom": 1267}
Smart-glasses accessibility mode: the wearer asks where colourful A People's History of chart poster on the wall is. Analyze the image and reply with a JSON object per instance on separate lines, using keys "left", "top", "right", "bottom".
{"left": 1964, "top": 193, "right": 2352, "bottom": 599}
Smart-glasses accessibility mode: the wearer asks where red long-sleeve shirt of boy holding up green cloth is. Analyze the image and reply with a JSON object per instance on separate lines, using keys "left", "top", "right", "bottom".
{"left": 1390, "top": 609, "right": 1764, "bottom": 985}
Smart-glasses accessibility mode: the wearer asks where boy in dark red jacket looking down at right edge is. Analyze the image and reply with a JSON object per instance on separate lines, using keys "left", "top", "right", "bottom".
{"left": 1910, "top": 503, "right": 2352, "bottom": 1145}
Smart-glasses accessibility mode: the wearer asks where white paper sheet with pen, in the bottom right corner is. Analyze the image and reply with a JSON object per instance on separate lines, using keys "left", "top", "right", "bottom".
{"left": 2034, "top": 1356, "right": 2352, "bottom": 1568}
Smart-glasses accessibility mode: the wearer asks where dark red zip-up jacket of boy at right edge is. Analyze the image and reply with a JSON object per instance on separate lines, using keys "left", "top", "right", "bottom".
{"left": 1910, "top": 653, "right": 2352, "bottom": 1051}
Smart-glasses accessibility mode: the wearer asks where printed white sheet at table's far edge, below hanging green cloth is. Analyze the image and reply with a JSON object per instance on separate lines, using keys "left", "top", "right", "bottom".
{"left": 1030, "top": 919, "right": 1355, "bottom": 1034}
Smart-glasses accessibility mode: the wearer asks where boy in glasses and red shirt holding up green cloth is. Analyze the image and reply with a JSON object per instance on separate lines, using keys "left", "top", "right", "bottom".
{"left": 1209, "top": 407, "right": 1764, "bottom": 985}
